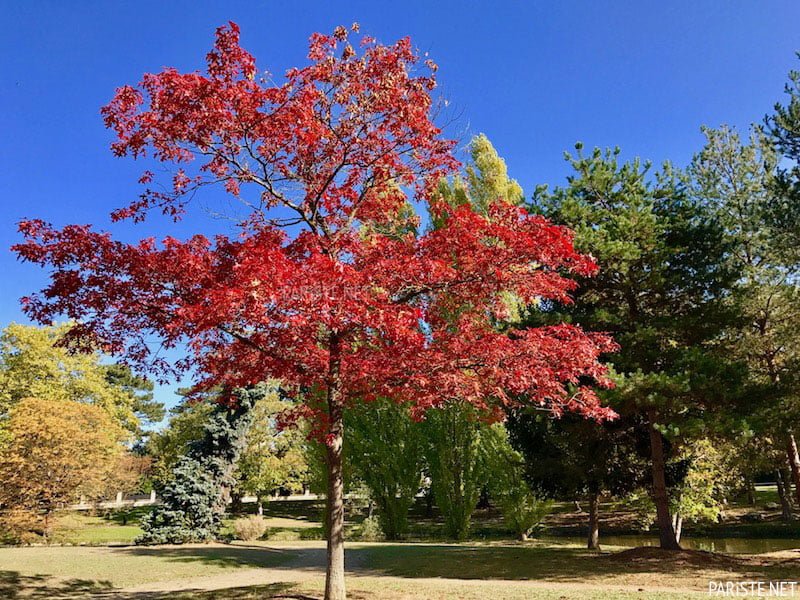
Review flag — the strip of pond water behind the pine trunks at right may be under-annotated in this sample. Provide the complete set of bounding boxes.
[541,534,800,554]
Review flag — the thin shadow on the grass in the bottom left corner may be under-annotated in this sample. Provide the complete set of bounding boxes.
[0,571,317,600]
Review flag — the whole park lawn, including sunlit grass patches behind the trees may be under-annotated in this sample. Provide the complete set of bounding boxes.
[0,488,800,600]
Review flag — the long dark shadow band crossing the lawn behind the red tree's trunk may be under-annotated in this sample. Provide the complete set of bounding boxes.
[109,543,800,582]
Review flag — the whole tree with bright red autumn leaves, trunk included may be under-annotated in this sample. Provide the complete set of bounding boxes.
[15,23,612,599]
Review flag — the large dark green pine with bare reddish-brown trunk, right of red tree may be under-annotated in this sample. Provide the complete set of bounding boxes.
[531,144,737,549]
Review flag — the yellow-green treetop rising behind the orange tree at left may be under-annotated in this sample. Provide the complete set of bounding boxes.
[0,323,159,432]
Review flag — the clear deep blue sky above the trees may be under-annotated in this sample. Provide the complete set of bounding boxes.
[0,0,800,412]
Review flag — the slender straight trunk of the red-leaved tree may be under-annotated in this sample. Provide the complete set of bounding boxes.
[325,334,347,600]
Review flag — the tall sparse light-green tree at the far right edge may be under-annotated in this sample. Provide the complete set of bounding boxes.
[690,125,800,501]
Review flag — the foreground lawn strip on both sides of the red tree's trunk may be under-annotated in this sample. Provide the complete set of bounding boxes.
[0,542,800,599]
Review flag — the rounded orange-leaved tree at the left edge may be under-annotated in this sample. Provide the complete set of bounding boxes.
[0,398,126,540]
